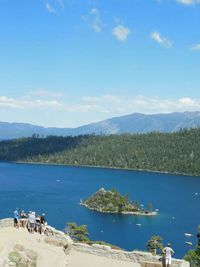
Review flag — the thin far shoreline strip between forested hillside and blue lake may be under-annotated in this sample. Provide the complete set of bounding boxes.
[9,161,200,177]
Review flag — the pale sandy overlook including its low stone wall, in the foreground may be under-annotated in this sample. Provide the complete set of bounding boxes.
[0,219,189,267]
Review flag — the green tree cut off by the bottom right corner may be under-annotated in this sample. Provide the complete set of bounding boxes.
[184,225,200,267]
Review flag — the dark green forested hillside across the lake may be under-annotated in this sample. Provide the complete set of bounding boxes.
[0,129,200,175]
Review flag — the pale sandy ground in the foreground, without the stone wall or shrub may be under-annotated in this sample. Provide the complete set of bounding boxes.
[0,227,140,267]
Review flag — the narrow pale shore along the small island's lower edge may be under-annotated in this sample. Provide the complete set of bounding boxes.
[80,202,158,216]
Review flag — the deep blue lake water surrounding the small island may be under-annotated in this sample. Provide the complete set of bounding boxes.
[0,162,200,257]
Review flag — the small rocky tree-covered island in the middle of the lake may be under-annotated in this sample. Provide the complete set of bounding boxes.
[80,188,157,216]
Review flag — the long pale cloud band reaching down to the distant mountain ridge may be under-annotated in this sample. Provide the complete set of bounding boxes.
[0,94,200,127]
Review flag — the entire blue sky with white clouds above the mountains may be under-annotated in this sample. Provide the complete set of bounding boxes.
[0,0,200,127]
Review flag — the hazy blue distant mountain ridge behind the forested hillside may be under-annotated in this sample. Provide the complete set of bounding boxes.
[0,111,200,140]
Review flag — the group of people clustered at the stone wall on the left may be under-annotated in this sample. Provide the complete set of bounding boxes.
[14,208,47,235]
